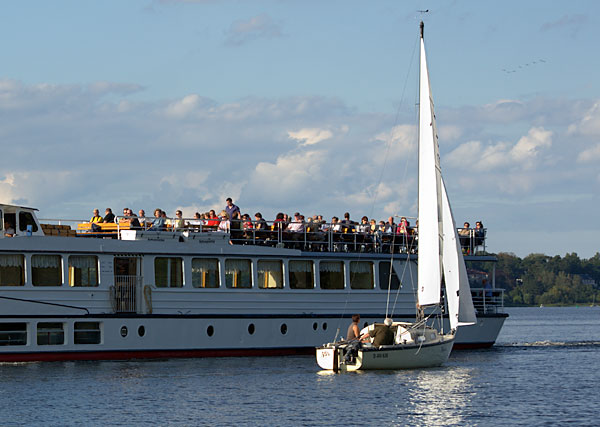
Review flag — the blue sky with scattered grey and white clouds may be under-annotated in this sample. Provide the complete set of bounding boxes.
[0,0,600,258]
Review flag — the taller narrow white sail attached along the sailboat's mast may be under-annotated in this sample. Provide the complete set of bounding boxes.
[417,23,442,306]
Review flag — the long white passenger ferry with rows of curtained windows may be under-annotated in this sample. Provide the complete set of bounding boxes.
[0,204,507,362]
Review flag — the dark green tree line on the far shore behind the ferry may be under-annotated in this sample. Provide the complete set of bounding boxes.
[468,252,600,305]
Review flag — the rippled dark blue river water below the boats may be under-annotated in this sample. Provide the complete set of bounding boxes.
[0,307,600,426]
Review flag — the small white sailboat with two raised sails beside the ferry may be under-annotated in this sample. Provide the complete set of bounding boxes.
[316,22,477,372]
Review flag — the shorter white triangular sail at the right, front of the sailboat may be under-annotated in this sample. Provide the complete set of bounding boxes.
[442,178,477,329]
